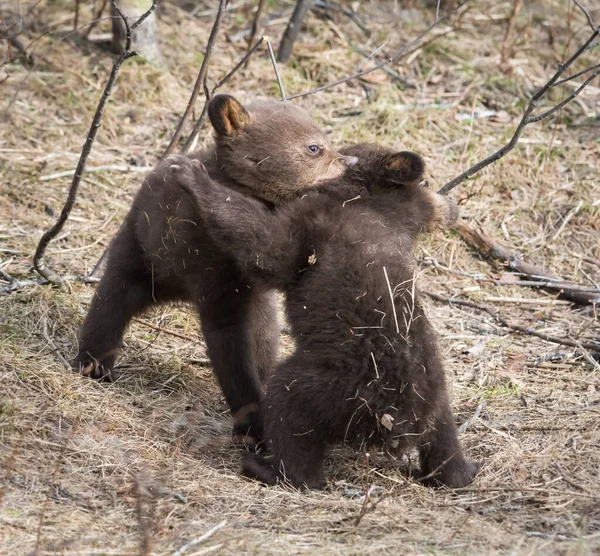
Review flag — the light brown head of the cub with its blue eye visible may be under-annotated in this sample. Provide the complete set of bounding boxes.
[208,95,358,202]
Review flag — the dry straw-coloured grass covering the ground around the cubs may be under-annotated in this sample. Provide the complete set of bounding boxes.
[0,0,600,554]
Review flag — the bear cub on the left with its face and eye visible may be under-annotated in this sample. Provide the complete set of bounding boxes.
[74,95,356,444]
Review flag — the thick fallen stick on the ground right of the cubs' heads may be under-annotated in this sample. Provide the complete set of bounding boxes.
[454,222,600,305]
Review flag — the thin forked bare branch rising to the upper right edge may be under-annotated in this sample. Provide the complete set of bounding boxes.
[438,21,600,194]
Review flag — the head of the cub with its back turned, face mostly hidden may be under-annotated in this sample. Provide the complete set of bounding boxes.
[342,143,458,232]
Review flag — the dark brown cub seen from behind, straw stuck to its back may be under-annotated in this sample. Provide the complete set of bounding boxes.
[166,145,479,488]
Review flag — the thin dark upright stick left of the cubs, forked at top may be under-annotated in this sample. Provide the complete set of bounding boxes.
[33,0,157,285]
